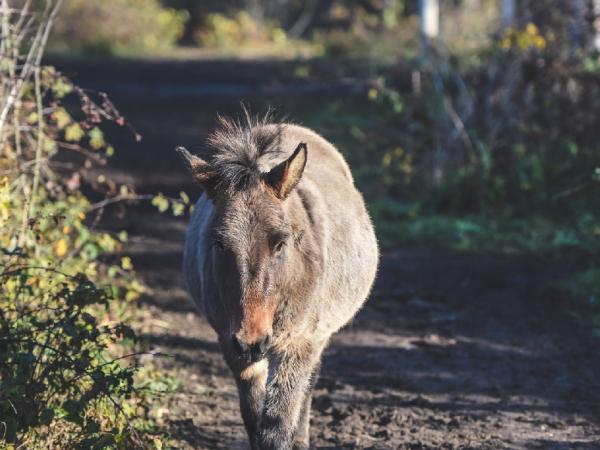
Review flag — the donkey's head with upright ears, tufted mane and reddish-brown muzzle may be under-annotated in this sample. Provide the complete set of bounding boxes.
[173,121,307,362]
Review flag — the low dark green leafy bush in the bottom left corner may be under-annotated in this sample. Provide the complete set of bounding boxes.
[0,264,135,448]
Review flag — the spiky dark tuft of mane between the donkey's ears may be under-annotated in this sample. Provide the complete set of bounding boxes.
[208,108,283,192]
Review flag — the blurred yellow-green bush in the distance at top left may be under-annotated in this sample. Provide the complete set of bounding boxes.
[50,0,188,55]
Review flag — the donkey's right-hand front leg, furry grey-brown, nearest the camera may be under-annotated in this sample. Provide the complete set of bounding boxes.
[258,350,318,450]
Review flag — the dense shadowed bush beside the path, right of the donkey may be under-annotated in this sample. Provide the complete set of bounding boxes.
[307,23,600,252]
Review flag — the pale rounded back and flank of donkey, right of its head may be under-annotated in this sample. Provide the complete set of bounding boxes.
[274,125,378,338]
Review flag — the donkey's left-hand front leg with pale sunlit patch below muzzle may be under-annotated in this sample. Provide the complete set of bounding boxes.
[234,359,268,450]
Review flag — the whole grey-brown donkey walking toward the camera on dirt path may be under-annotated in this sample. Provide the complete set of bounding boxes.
[177,112,379,450]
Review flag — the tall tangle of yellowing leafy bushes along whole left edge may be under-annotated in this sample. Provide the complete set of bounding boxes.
[0,2,155,449]
